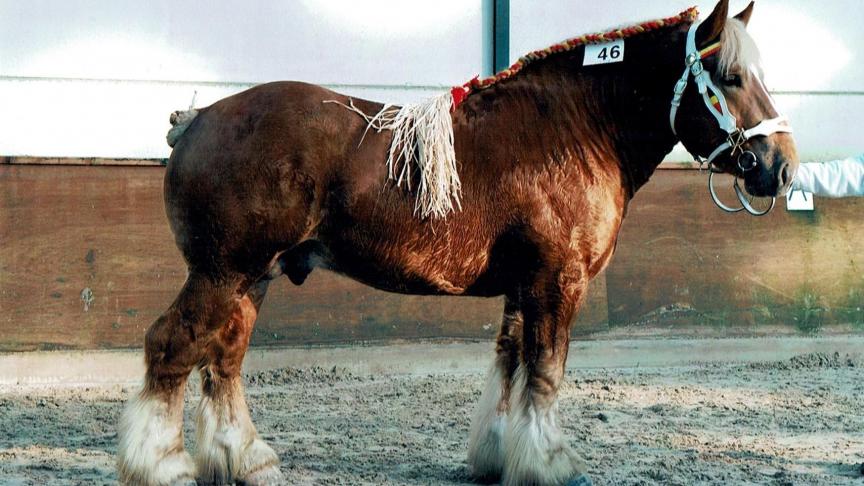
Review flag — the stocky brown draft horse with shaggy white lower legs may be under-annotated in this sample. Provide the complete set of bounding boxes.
[119,0,797,485]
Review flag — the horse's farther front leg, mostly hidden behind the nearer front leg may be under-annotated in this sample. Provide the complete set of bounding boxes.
[468,297,522,482]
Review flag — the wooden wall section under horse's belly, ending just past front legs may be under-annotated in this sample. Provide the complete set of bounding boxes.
[253,271,608,345]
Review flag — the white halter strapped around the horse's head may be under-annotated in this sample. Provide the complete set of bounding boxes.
[669,22,792,165]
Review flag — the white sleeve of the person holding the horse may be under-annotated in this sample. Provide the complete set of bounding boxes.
[792,154,864,197]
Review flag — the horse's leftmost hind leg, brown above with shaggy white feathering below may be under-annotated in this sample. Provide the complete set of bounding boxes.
[118,273,241,486]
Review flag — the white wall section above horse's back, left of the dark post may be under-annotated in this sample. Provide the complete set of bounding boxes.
[0,0,484,157]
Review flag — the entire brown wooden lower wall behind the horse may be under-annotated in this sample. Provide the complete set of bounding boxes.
[0,164,864,350]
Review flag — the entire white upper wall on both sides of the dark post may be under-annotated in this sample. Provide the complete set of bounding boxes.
[0,0,864,160]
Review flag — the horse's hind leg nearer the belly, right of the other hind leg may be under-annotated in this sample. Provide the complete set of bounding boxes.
[195,280,284,486]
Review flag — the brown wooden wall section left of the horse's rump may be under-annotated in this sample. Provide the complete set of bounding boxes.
[0,165,185,349]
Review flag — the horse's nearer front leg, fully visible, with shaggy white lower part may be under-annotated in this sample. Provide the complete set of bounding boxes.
[502,265,591,486]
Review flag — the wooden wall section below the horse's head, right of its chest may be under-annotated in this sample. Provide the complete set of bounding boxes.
[606,171,864,332]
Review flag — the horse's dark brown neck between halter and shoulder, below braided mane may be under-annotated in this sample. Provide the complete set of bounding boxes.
[486,29,680,197]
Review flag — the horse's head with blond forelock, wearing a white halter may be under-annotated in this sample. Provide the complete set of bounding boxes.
[670,0,798,196]
